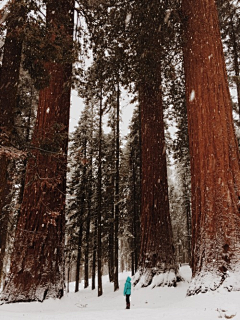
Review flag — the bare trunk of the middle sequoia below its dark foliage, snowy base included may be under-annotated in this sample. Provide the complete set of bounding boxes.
[134,79,177,286]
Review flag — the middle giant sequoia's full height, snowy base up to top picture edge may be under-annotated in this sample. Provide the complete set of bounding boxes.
[132,1,178,286]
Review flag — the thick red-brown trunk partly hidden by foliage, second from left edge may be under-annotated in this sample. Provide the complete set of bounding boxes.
[1,0,74,302]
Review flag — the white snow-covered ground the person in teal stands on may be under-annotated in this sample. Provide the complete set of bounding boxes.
[0,266,240,320]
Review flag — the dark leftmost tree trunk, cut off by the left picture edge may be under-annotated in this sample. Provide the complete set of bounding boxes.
[0,0,26,285]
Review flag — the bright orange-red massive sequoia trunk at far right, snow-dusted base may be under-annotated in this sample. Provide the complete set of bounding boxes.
[182,0,240,295]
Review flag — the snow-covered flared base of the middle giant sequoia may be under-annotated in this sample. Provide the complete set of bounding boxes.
[132,268,183,288]
